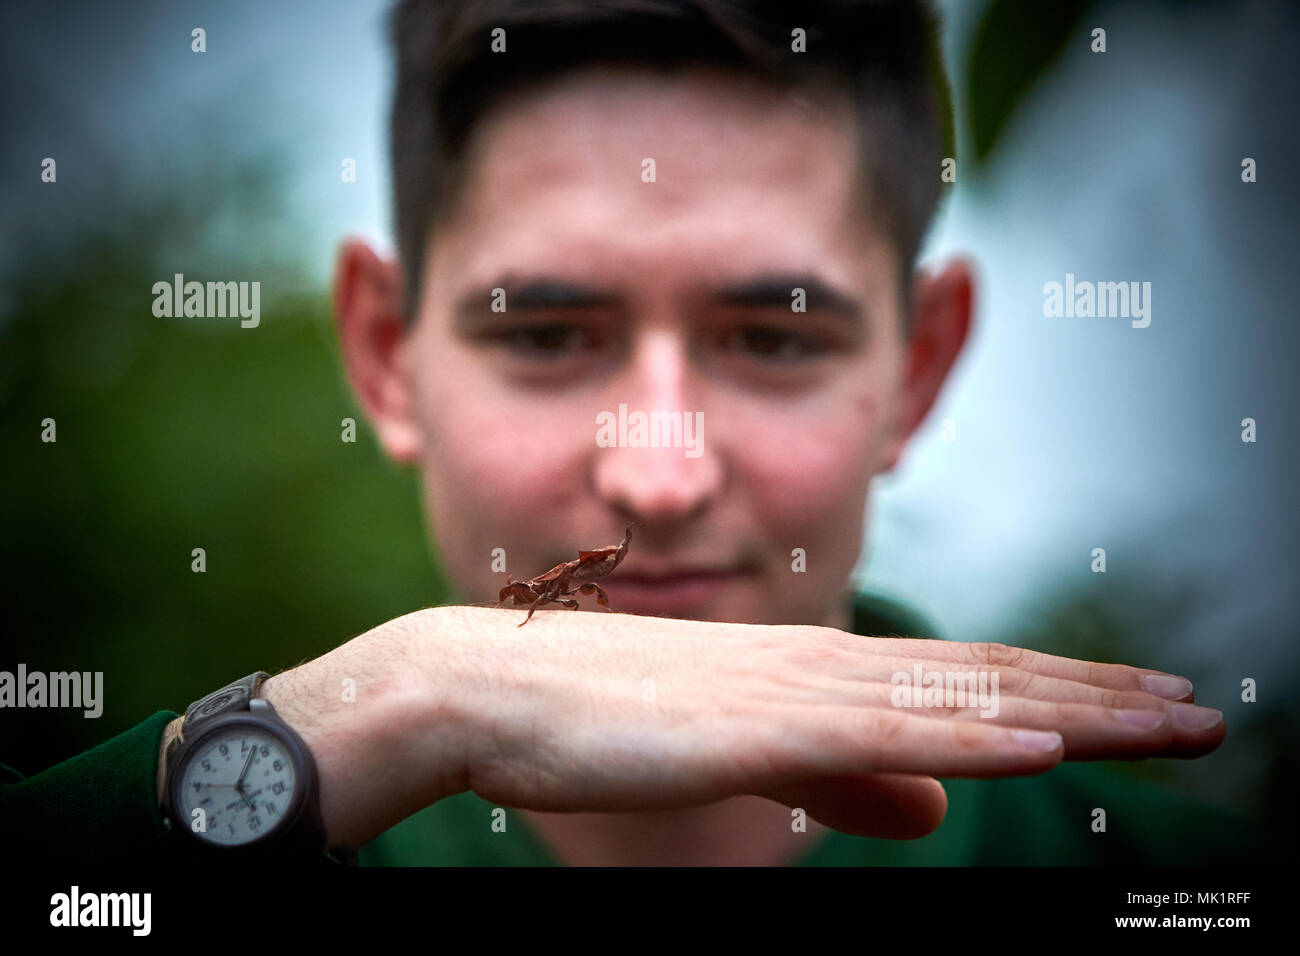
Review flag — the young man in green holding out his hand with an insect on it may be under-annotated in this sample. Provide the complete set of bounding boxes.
[0,0,1253,864]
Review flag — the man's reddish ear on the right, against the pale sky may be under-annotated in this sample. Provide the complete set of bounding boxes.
[885,259,975,470]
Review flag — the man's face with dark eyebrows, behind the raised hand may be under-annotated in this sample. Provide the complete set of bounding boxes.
[381,70,946,627]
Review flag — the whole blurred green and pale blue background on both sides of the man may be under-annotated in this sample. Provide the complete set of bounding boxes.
[0,0,1300,858]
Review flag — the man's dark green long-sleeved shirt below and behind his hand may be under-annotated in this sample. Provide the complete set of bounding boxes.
[0,596,1281,866]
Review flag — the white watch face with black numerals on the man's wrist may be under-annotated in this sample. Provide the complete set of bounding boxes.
[176,723,296,847]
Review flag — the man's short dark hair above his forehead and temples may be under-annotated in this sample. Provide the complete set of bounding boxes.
[390,0,954,321]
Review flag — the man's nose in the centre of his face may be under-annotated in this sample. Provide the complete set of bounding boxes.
[593,329,723,524]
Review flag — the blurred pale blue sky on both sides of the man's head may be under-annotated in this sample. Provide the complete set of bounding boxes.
[0,0,1300,683]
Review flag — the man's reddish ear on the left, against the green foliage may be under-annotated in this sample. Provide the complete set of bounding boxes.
[334,239,420,464]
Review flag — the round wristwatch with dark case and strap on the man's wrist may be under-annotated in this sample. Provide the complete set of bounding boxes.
[163,671,356,866]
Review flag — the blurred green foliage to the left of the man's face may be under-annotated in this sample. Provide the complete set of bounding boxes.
[0,164,446,774]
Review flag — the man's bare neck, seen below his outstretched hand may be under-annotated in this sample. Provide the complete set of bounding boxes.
[520,596,853,866]
